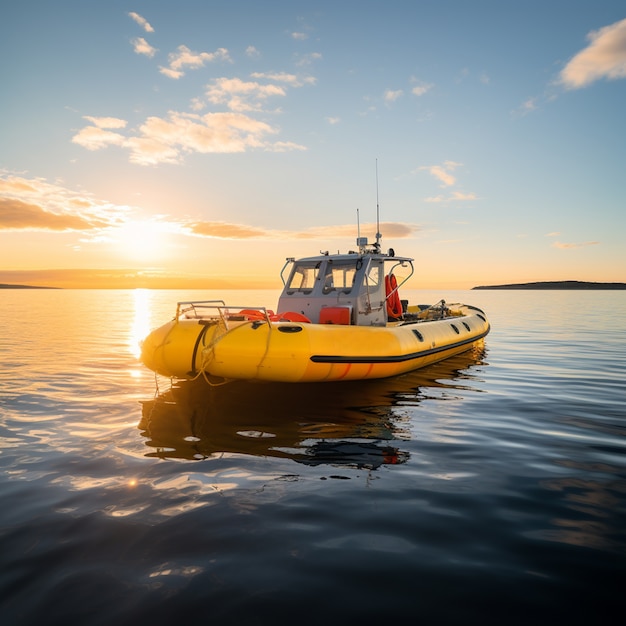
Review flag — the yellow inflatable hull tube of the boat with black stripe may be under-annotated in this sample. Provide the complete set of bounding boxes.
[141,311,489,383]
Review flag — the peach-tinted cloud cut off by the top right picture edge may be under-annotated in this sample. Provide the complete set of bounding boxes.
[559,18,626,89]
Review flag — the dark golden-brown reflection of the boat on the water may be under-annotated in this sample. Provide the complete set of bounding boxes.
[138,346,484,469]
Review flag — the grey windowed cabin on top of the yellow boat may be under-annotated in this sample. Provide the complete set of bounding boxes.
[277,241,413,326]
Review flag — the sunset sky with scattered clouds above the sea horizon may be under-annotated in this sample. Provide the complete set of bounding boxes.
[0,0,626,289]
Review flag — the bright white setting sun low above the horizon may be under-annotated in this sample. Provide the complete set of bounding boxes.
[112,220,168,263]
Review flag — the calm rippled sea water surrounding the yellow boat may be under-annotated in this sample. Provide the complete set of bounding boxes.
[0,290,626,626]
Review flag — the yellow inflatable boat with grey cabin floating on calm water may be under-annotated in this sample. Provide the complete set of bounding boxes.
[141,234,490,384]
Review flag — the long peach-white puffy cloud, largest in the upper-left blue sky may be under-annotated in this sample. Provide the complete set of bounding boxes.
[72,111,306,165]
